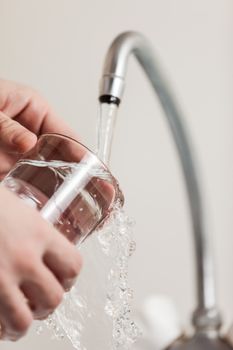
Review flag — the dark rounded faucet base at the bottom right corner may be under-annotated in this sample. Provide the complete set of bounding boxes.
[167,334,233,350]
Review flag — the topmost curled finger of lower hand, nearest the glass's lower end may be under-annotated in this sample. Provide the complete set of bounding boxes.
[43,233,82,290]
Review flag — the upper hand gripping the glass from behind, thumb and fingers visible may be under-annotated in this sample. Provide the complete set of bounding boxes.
[0,79,77,179]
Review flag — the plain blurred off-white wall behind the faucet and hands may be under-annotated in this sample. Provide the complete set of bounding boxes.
[0,0,233,350]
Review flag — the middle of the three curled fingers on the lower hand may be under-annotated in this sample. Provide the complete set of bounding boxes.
[20,263,64,319]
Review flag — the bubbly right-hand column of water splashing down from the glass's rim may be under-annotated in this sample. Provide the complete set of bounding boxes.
[99,204,141,350]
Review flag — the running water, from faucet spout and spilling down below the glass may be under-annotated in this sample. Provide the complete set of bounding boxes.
[32,104,140,350]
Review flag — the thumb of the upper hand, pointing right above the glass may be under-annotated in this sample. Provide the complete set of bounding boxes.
[0,112,37,153]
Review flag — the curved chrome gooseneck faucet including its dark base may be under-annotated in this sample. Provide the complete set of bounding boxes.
[99,32,232,350]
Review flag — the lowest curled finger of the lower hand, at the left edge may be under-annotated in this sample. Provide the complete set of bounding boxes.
[0,283,33,340]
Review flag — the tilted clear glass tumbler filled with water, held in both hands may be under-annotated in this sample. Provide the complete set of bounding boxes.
[2,134,124,244]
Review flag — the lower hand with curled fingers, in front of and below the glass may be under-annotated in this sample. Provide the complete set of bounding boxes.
[0,186,82,340]
